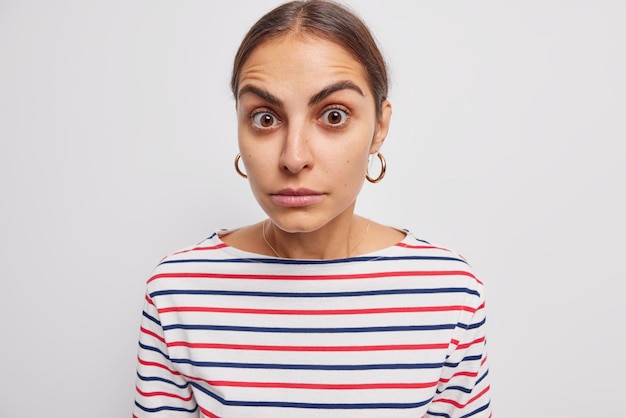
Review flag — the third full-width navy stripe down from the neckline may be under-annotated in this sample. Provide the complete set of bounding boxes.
[163,324,455,334]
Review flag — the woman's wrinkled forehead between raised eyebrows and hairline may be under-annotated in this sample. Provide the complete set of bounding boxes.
[238,34,371,99]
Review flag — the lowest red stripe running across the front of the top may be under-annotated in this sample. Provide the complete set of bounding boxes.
[194,380,437,390]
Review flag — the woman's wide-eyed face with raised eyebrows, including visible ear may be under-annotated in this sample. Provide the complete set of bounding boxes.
[237,35,391,232]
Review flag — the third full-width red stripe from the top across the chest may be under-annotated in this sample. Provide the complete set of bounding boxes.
[167,341,448,352]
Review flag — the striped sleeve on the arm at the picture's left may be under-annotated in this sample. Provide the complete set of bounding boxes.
[133,295,199,418]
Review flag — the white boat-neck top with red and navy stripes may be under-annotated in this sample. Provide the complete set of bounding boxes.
[133,233,491,418]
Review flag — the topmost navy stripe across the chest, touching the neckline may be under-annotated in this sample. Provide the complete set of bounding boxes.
[159,255,468,265]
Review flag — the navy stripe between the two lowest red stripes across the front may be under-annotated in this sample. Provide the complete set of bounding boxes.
[171,358,442,371]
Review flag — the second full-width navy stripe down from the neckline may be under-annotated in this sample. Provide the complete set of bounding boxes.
[150,287,480,299]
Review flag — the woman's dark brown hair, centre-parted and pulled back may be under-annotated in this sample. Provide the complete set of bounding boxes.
[230,0,389,116]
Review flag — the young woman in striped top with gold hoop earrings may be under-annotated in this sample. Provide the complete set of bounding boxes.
[134,0,491,418]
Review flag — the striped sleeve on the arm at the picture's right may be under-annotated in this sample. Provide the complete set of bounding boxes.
[425,282,491,418]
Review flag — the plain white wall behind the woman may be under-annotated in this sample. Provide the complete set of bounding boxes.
[0,0,626,418]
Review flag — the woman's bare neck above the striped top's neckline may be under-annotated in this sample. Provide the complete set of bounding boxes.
[262,214,370,260]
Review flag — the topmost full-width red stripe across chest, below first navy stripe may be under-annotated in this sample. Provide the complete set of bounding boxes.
[148,270,481,283]
